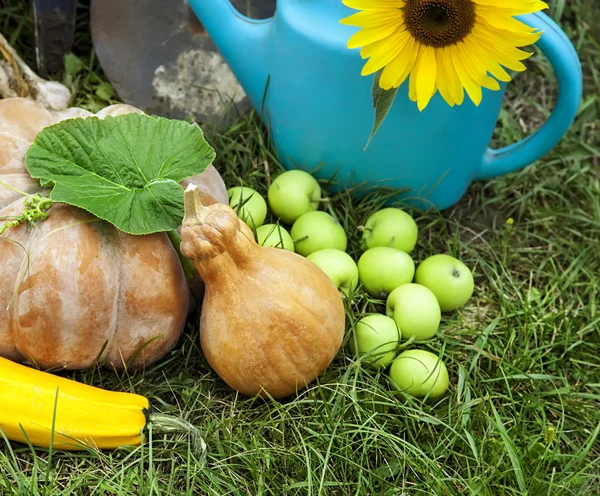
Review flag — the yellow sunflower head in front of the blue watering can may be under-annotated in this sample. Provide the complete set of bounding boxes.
[340,0,548,110]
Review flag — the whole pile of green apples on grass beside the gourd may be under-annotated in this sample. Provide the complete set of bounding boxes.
[228,170,474,400]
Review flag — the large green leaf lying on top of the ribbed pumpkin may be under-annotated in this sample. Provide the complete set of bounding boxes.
[25,113,215,234]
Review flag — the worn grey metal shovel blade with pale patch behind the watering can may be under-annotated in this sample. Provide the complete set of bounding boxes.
[90,0,276,124]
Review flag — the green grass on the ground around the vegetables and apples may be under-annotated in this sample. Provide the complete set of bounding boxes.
[0,0,600,496]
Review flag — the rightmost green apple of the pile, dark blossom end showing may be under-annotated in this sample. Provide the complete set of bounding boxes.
[415,254,475,312]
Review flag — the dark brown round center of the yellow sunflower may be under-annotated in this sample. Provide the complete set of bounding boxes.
[404,0,475,48]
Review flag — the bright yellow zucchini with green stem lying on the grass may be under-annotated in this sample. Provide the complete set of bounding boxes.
[0,358,206,453]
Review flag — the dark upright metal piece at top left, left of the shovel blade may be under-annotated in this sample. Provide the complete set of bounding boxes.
[33,0,77,77]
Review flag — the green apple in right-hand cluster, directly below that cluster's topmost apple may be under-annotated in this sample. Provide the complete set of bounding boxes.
[358,246,415,298]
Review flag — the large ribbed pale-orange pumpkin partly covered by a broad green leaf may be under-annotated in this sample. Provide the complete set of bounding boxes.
[0,98,227,369]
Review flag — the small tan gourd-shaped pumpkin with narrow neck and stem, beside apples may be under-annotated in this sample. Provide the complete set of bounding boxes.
[181,186,345,398]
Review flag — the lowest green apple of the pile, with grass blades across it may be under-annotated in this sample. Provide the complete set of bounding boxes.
[389,349,449,400]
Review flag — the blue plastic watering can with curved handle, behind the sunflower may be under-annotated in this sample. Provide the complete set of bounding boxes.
[189,0,582,209]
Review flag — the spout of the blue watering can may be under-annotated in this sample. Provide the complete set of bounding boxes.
[188,0,272,107]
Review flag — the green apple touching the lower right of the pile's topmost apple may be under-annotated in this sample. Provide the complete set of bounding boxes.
[290,210,348,257]
